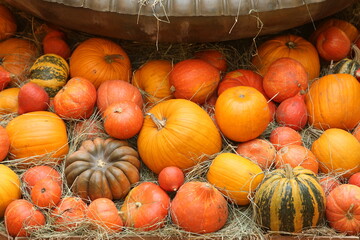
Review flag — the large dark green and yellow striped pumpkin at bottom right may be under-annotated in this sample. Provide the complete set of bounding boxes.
[254,164,325,232]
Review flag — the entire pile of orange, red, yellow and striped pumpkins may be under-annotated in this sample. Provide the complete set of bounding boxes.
[0,2,360,237]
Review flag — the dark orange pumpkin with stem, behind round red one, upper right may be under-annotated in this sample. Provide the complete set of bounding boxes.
[251,34,320,80]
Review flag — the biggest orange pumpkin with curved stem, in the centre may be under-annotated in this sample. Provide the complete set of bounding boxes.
[137,99,222,174]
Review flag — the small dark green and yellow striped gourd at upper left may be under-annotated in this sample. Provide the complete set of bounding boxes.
[29,54,69,97]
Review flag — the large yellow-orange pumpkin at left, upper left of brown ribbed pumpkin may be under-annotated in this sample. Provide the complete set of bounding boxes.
[6,111,69,167]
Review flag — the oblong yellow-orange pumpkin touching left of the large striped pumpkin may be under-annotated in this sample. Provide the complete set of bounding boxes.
[206,153,264,205]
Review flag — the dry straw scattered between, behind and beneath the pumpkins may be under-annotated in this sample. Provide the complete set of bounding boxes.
[0,1,360,239]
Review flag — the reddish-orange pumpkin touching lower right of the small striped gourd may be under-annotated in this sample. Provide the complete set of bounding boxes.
[54,77,96,119]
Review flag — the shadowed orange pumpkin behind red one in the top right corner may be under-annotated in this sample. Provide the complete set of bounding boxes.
[309,18,360,44]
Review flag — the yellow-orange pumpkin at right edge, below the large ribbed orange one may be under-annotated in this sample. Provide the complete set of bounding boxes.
[311,128,360,178]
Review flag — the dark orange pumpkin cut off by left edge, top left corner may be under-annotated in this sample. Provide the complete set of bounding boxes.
[0,5,17,40]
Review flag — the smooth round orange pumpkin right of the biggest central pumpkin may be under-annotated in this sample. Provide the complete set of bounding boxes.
[215,86,270,142]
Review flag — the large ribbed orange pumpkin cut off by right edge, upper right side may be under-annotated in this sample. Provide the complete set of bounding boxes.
[305,74,360,130]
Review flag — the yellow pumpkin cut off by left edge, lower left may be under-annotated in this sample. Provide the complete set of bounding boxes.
[0,164,21,218]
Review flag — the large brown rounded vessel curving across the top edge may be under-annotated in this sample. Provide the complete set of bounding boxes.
[5,0,356,42]
